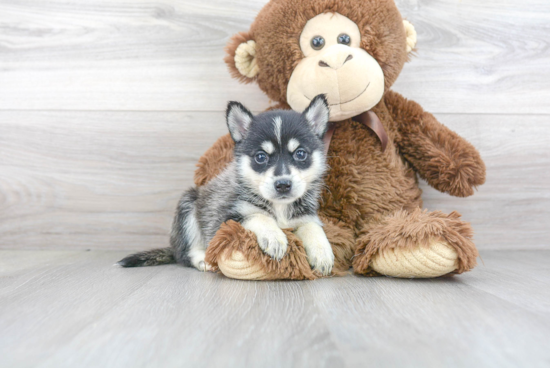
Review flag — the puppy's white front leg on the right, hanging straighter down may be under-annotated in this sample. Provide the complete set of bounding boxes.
[294,222,334,276]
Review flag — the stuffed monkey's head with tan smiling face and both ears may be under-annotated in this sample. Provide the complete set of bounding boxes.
[225,0,416,121]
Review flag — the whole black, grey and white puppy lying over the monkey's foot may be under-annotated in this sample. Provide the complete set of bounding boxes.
[118,95,334,275]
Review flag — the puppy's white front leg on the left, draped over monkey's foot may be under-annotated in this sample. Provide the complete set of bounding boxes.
[242,214,288,261]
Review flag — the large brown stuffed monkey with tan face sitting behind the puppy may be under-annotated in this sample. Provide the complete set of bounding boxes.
[201,0,485,279]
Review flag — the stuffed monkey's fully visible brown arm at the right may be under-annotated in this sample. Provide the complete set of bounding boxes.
[385,91,485,197]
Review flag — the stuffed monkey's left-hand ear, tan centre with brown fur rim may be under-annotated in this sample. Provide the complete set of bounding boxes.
[224,32,259,83]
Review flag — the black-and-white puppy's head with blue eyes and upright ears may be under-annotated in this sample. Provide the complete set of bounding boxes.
[228,96,329,203]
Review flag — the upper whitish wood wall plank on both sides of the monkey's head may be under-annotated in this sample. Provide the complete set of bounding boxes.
[0,0,550,114]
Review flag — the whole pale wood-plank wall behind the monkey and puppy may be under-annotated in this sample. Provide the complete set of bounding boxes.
[0,0,550,249]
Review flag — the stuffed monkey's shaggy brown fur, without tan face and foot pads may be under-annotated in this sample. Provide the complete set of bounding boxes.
[199,0,485,279]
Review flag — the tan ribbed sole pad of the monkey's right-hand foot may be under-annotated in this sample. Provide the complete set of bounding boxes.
[370,241,458,278]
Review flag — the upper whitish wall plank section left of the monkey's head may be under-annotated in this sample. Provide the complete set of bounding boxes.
[0,0,267,111]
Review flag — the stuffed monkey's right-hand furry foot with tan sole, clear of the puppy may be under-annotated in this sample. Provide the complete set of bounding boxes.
[353,209,478,278]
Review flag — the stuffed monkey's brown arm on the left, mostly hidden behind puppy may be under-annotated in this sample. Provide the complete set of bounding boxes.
[194,134,235,187]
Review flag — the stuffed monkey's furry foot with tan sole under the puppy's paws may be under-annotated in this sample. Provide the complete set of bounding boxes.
[206,221,319,280]
